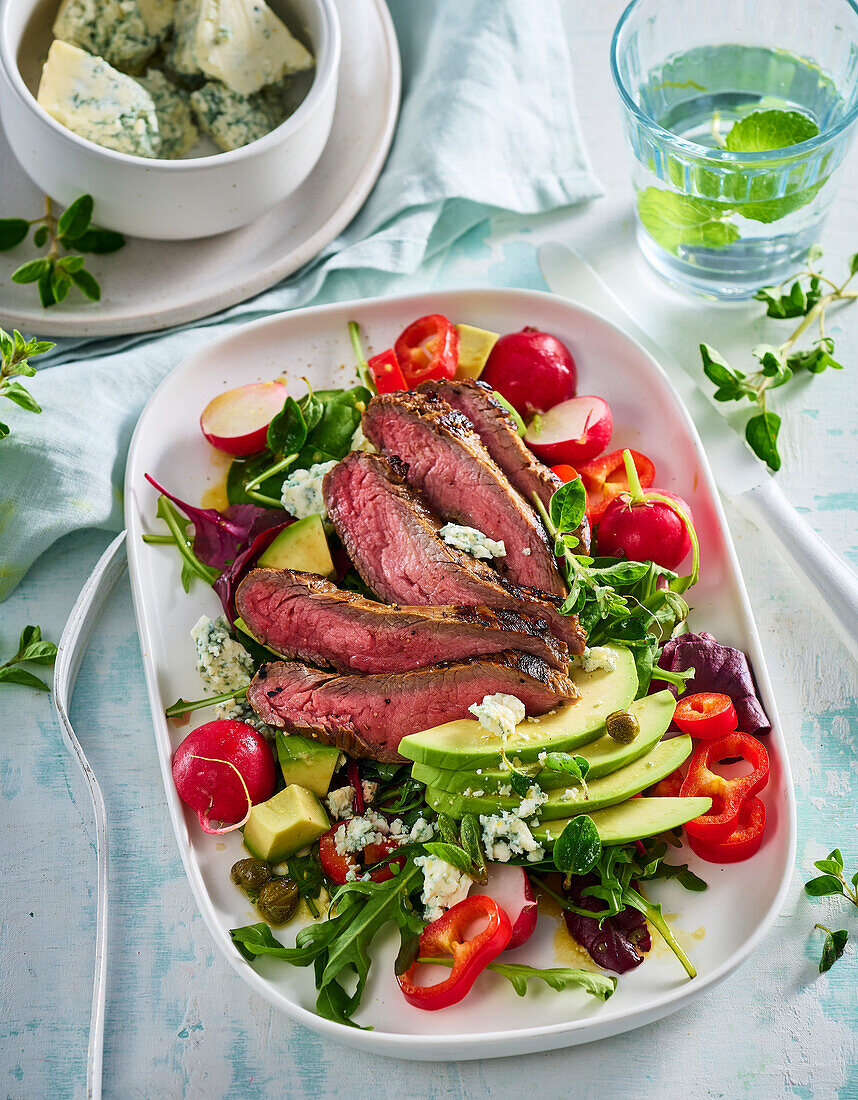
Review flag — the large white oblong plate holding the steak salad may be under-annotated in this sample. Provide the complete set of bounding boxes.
[125,290,795,1059]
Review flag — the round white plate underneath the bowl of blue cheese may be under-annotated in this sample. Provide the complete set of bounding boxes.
[0,0,400,337]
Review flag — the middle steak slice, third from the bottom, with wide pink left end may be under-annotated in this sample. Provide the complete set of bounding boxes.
[322,451,584,653]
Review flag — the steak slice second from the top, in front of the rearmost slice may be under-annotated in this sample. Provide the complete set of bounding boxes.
[363,392,565,596]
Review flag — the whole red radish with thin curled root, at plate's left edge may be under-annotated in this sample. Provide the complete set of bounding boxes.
[173,718,275,833]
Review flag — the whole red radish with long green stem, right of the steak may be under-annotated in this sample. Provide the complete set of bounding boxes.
[596,451,700,584]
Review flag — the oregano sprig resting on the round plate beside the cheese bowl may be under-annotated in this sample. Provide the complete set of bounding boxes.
[0,195,125,309]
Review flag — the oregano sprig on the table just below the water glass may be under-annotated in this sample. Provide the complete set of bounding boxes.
[700,248,858,472]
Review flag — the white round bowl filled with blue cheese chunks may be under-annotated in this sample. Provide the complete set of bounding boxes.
[0,0,340,240]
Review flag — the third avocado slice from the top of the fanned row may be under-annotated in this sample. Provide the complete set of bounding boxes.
[426,734,692,821]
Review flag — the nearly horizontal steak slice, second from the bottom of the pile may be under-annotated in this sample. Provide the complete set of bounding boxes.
[235,569,569,672]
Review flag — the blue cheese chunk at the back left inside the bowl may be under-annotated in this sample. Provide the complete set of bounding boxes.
[54,0,163,72]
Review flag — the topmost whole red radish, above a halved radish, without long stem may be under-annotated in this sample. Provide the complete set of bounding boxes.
[480,327,578,419]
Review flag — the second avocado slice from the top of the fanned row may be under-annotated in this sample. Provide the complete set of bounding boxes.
[411,691,677,794]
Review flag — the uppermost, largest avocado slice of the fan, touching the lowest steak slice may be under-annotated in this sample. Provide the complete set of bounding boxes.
[398,646,638,771]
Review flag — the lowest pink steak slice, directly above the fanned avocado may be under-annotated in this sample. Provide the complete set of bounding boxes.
[248,653,579,761]
